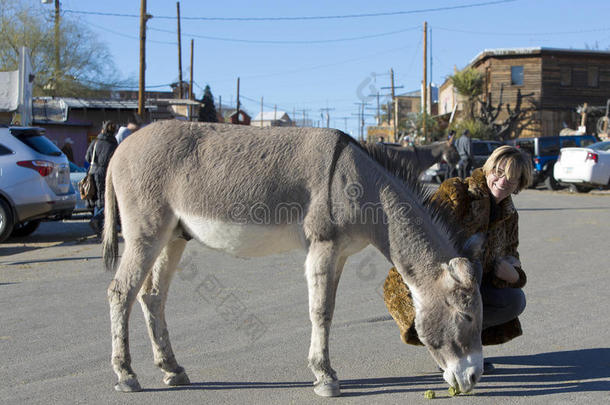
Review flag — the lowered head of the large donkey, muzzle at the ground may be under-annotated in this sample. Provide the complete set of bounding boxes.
[413,235,483,392]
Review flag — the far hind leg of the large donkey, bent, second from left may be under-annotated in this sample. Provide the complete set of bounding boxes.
[138,239,190,386]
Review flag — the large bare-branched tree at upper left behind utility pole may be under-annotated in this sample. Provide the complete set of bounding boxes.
[0,0,127,97]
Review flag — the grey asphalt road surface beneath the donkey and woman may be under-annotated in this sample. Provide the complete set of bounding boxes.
[0,190,610,405]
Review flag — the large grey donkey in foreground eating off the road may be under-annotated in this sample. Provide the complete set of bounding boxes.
[103,121,483,396]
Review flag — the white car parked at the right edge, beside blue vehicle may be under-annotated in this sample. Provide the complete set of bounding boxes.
[553,141,610,191]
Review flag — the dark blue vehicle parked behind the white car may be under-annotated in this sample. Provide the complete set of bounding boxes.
[509,135,597,190]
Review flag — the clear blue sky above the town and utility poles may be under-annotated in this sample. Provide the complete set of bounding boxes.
[53,0,610,135]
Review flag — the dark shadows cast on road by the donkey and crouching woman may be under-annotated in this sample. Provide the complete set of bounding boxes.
[144,348,610,397]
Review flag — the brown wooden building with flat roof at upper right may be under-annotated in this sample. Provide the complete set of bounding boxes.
[466,48,610,137]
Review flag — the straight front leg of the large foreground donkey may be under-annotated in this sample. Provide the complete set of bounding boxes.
[305,242,345,397]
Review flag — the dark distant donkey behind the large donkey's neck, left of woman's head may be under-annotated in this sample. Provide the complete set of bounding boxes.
[375,138,460,177]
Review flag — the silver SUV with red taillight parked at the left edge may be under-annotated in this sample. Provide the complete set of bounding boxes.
[0,127,76,242]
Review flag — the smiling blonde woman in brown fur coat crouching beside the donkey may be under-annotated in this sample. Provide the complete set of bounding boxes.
[384,146,532,372]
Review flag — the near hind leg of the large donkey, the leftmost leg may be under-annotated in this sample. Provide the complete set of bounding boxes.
[108,234,169,392]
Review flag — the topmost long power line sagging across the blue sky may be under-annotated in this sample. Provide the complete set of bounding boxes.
[63,0,517,21]
